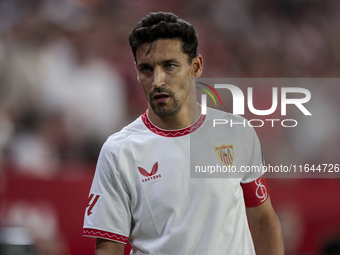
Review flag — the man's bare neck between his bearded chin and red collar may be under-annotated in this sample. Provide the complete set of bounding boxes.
[148,101,201,130]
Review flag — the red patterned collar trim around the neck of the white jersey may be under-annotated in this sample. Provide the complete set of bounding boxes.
[142,112,206,137]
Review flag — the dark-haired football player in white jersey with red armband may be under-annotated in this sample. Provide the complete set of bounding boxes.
[84,13,283,255]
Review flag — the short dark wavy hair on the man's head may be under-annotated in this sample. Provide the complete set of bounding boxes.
[129,12,198,64]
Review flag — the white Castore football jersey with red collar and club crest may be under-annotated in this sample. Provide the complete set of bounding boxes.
[83,108,268,255]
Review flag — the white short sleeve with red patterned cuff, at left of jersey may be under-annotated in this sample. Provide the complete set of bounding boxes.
[83,136,131,243]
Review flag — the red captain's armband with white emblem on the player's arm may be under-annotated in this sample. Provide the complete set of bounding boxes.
[241,176,269,207]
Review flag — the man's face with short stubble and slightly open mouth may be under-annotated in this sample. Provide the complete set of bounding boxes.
[136,39,192,117]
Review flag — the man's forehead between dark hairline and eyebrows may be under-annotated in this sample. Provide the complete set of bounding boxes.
[136,39,187,63]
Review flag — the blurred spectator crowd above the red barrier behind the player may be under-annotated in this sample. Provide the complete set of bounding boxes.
[0,0,340,254]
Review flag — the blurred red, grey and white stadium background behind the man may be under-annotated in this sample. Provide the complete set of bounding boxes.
[0,0,340,255]
